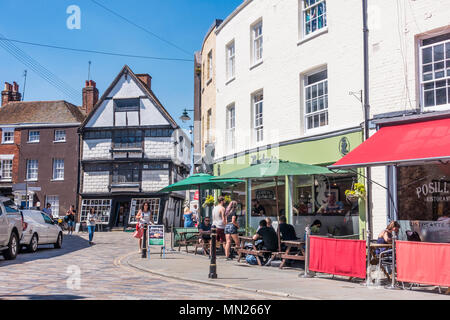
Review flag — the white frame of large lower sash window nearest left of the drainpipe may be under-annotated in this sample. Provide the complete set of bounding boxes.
[303,67,329,133]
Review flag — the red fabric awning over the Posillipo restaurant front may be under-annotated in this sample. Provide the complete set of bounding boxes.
[329,119,450,169]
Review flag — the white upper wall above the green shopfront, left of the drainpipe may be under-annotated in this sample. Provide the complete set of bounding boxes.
[216,0,363,158]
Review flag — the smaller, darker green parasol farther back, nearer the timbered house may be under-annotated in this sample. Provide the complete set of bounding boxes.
[160,173,245,192]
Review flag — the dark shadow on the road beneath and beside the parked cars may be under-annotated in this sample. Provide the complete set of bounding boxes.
[0,235,90,268]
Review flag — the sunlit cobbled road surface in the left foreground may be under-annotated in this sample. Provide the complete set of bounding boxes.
[0,232,282,300]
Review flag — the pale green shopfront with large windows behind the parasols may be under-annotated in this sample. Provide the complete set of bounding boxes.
[214,127,366,238]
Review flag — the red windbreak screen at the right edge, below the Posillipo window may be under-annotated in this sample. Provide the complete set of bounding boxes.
[395,241,450,287]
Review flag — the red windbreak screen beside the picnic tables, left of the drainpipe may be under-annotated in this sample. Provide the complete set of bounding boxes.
[309,237,366,279]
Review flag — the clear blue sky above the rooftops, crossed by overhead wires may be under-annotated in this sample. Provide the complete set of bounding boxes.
[0,0,242,127]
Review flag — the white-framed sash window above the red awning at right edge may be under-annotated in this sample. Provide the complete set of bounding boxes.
[420,33,450,107]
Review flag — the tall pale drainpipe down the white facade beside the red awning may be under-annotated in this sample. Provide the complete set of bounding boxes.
[362,0,372,239]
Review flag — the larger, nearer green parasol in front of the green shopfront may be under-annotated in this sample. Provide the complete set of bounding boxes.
[212,160,334,181]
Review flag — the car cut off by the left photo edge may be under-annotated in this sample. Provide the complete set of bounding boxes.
[0,197,25,260]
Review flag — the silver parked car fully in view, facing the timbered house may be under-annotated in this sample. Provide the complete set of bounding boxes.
[21,210,63,252]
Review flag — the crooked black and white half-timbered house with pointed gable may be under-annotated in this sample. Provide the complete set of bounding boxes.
[79,66,191,228]
